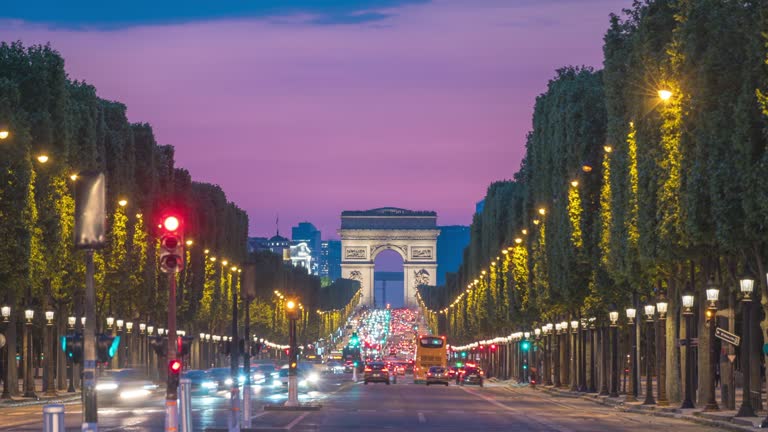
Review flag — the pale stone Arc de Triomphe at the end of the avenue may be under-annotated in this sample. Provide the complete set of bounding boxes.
[339,207,440,307]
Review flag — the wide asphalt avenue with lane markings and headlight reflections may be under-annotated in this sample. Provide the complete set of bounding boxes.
[0,375,732,432]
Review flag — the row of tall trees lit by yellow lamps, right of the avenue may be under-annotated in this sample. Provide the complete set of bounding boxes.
[420,0,768,404]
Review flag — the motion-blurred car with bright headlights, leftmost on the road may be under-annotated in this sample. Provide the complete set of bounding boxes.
[96,369,158,404]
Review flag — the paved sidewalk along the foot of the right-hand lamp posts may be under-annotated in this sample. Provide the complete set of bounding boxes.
[520,382,763,431]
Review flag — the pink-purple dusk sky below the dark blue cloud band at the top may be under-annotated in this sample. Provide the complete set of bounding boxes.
[0,0,631,238]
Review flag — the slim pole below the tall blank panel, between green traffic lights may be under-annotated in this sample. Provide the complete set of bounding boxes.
[82,249,99,432]
